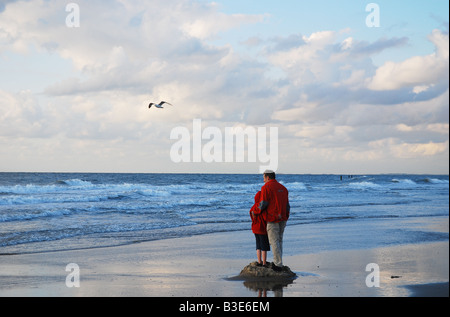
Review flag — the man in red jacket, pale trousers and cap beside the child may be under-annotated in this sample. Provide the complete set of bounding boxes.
[259,170,291,271]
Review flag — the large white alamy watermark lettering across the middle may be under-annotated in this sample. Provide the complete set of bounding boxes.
[170,119,278,173]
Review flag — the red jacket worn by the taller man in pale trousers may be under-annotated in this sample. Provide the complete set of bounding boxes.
[259,179,291,222]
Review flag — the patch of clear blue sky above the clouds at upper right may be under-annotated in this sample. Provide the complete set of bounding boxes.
[217,0,448,62]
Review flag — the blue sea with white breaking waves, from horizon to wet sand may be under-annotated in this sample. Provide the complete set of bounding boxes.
[0,173,449,255]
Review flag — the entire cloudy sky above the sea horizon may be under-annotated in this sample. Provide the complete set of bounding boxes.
[0,0,449,175]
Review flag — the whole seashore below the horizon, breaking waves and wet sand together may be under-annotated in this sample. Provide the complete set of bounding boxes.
[0,173,449,298]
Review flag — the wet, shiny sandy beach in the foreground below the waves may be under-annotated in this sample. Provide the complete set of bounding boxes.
[0,221,449,297]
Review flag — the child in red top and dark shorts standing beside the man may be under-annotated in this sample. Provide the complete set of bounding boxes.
[250,191,270,266]
